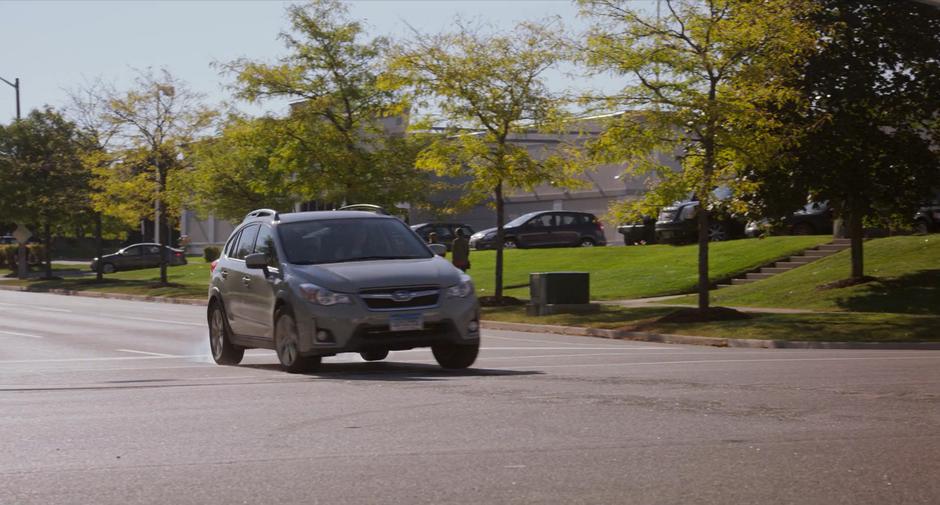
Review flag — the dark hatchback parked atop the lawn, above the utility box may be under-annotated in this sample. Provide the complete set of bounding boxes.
[470,210,607,249]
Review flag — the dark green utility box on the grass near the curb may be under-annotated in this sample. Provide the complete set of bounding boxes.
[527,272,600,316]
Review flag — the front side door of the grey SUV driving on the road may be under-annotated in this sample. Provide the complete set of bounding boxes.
[240,224,281,339]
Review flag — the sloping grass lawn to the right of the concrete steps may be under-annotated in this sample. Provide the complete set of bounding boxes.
[677,234,940,315]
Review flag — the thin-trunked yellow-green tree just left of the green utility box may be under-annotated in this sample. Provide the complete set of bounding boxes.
[388,22,574,300]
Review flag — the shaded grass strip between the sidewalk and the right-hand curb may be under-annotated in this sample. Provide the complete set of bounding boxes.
[483,306,940,342]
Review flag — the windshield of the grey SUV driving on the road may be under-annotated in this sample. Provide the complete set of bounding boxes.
[278,218,433,265]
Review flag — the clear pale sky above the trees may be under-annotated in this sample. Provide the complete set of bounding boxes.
[0,0,649,123]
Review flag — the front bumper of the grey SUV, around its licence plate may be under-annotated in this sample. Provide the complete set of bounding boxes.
[294,294,480,356]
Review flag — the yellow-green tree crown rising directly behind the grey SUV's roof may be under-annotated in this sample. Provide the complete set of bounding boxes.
[220,0,426,209]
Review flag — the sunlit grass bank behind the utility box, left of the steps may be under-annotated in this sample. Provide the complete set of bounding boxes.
[470,236,831,300]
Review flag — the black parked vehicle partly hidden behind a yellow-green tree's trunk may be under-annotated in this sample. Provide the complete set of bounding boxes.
[656,197,745,244]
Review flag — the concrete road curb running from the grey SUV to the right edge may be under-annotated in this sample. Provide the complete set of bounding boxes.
[481,320,940,350]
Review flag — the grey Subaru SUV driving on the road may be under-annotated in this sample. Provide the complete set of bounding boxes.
[208,209,480,372]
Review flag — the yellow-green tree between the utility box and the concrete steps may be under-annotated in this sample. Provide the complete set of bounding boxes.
[577,0,812,312]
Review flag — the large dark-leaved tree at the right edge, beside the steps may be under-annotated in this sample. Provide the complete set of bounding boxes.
[765,0,940,282]
